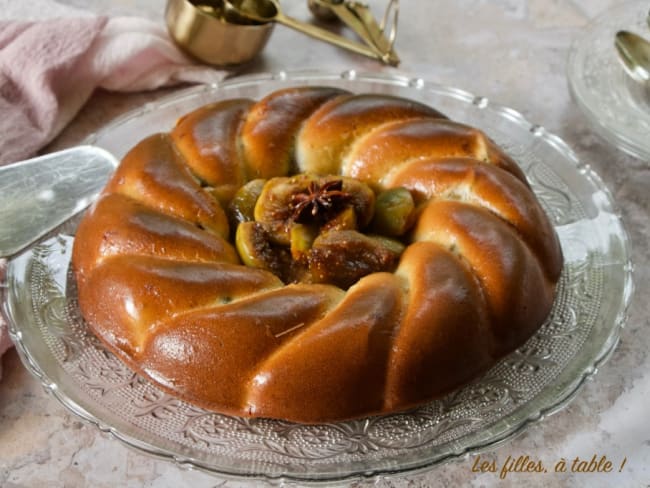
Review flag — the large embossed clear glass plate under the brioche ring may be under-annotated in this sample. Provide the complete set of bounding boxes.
[4,71,633,484]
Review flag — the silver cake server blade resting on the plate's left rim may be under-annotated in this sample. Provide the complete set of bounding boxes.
[0,146,118,257]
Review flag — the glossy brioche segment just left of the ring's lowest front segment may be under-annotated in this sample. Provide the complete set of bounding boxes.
[138,285,341,415]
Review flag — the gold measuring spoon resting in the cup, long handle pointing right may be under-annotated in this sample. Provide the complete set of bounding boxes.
[223,0,399,65]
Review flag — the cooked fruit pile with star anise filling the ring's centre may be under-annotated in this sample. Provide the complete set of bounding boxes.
[229,174,415,289]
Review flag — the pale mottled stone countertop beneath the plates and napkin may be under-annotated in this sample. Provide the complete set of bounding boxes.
[0,0,650,488]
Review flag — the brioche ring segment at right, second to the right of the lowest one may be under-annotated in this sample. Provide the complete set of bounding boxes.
[414,201,555,356]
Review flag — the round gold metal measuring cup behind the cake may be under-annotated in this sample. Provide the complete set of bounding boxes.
[165,0,274,66]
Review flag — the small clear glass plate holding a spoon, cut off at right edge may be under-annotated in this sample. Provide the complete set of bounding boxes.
[567,0,650,160]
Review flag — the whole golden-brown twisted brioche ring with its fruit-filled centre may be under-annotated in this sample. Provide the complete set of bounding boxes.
[73,87,562,423]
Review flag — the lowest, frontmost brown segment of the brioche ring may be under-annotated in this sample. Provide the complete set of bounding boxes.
[247,273,403,422]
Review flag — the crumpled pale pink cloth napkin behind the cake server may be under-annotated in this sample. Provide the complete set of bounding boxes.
[0,13,232,377]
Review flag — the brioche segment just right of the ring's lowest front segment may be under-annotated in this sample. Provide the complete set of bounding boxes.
[384,242,494,410]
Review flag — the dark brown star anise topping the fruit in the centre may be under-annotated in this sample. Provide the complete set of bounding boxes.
[291,180,352,224]
